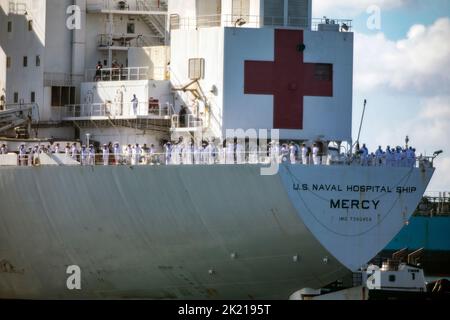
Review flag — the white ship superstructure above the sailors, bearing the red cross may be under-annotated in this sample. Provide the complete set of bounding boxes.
[0,0,353,144]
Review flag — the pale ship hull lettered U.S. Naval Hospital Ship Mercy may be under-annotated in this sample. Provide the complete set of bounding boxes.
[0,165,434,299]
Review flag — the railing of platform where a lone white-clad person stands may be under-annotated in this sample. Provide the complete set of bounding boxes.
[53,101,172,120]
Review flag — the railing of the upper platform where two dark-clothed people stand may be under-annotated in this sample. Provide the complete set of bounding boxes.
[84,67,167,82]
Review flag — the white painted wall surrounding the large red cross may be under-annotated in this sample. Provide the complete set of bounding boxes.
[223,28,353,141]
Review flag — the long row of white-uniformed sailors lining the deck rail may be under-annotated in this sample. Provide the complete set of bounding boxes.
[0,139,416,167]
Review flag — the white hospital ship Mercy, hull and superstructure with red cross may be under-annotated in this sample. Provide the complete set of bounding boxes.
[0,0,434,299]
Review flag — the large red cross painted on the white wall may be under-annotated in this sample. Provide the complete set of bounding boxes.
[244,30,333,129]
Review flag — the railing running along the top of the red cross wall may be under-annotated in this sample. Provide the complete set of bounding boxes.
[170,14,352,31]
